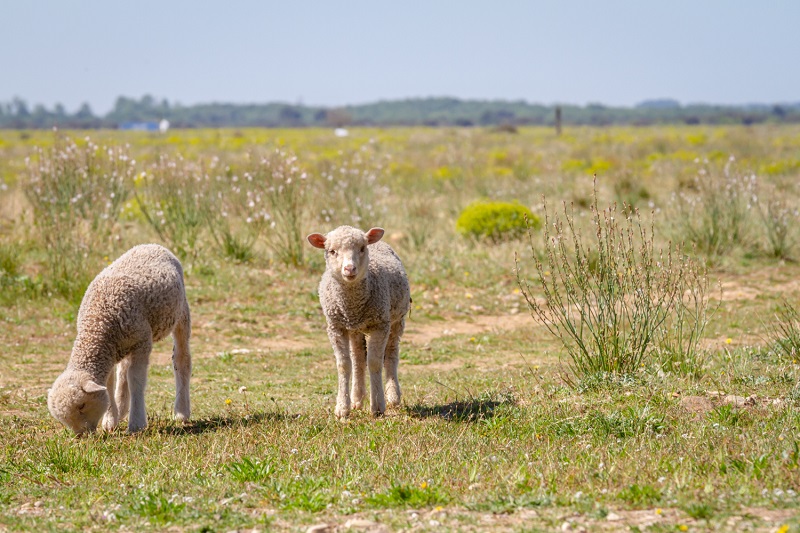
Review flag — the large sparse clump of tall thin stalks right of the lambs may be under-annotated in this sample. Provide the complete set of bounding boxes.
[517,182,692,380]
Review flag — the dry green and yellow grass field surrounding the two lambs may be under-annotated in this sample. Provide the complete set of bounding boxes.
[0,126,800,532]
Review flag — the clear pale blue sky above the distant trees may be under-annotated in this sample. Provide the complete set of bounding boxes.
[0,0,800,113]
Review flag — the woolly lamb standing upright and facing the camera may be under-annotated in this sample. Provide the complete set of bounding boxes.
[308,222,411,418]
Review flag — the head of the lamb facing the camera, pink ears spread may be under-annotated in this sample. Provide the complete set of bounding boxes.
[308,226,383,283]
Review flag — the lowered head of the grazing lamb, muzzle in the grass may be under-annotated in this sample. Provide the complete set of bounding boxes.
[47,368,109,435]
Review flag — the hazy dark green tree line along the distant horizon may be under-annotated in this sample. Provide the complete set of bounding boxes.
[0,95,800,129]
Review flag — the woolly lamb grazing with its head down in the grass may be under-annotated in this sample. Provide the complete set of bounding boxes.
[47,244,192,435]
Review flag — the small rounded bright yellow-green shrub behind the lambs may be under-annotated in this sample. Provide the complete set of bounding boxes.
[456,201,540,242]
